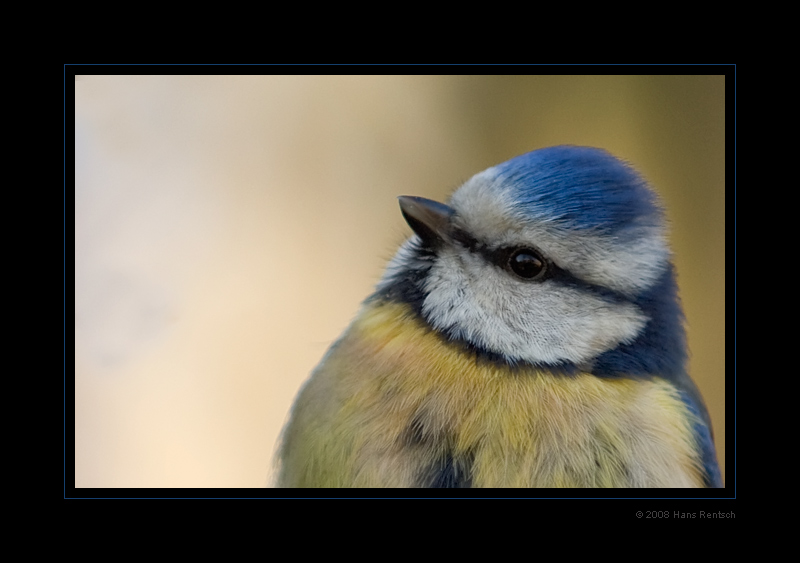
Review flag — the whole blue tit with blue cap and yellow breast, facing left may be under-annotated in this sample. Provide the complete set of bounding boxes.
[277,146,722,488]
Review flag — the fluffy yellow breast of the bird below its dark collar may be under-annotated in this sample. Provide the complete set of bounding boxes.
[279,303,702,487]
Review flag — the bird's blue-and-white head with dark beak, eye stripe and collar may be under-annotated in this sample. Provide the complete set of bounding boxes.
[375,146,685,376]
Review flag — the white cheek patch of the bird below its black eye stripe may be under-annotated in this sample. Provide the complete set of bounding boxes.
[423,251,647,363]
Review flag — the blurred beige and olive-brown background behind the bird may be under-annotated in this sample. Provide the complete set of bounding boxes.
[75,76,725,487]
